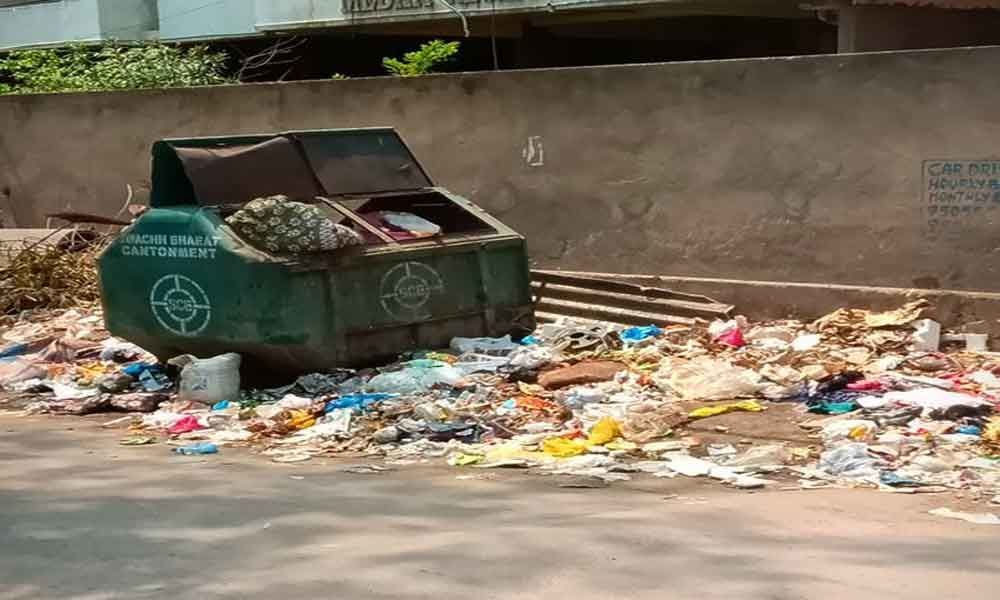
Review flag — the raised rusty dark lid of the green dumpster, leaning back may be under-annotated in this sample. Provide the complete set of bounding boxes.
[150,127,433,206]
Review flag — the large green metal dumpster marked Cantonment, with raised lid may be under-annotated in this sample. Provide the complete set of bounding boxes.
[99,128,534,373]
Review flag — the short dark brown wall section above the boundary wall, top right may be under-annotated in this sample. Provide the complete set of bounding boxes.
[837,6,1000,52]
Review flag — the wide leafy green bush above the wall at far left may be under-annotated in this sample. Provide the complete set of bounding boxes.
[0,44,234,94]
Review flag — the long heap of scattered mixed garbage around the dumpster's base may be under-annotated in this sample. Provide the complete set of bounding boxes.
[0,301,1000,498]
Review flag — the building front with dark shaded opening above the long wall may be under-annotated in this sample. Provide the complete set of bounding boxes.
[0,0,1000,61]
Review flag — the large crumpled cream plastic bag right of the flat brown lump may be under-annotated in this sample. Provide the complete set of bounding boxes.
[658,357,761,400]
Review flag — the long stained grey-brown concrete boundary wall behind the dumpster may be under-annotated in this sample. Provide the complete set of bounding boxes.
[0,48,1000,291]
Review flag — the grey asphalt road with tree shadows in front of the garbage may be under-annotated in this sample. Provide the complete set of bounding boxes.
[0,416,1000,600]
